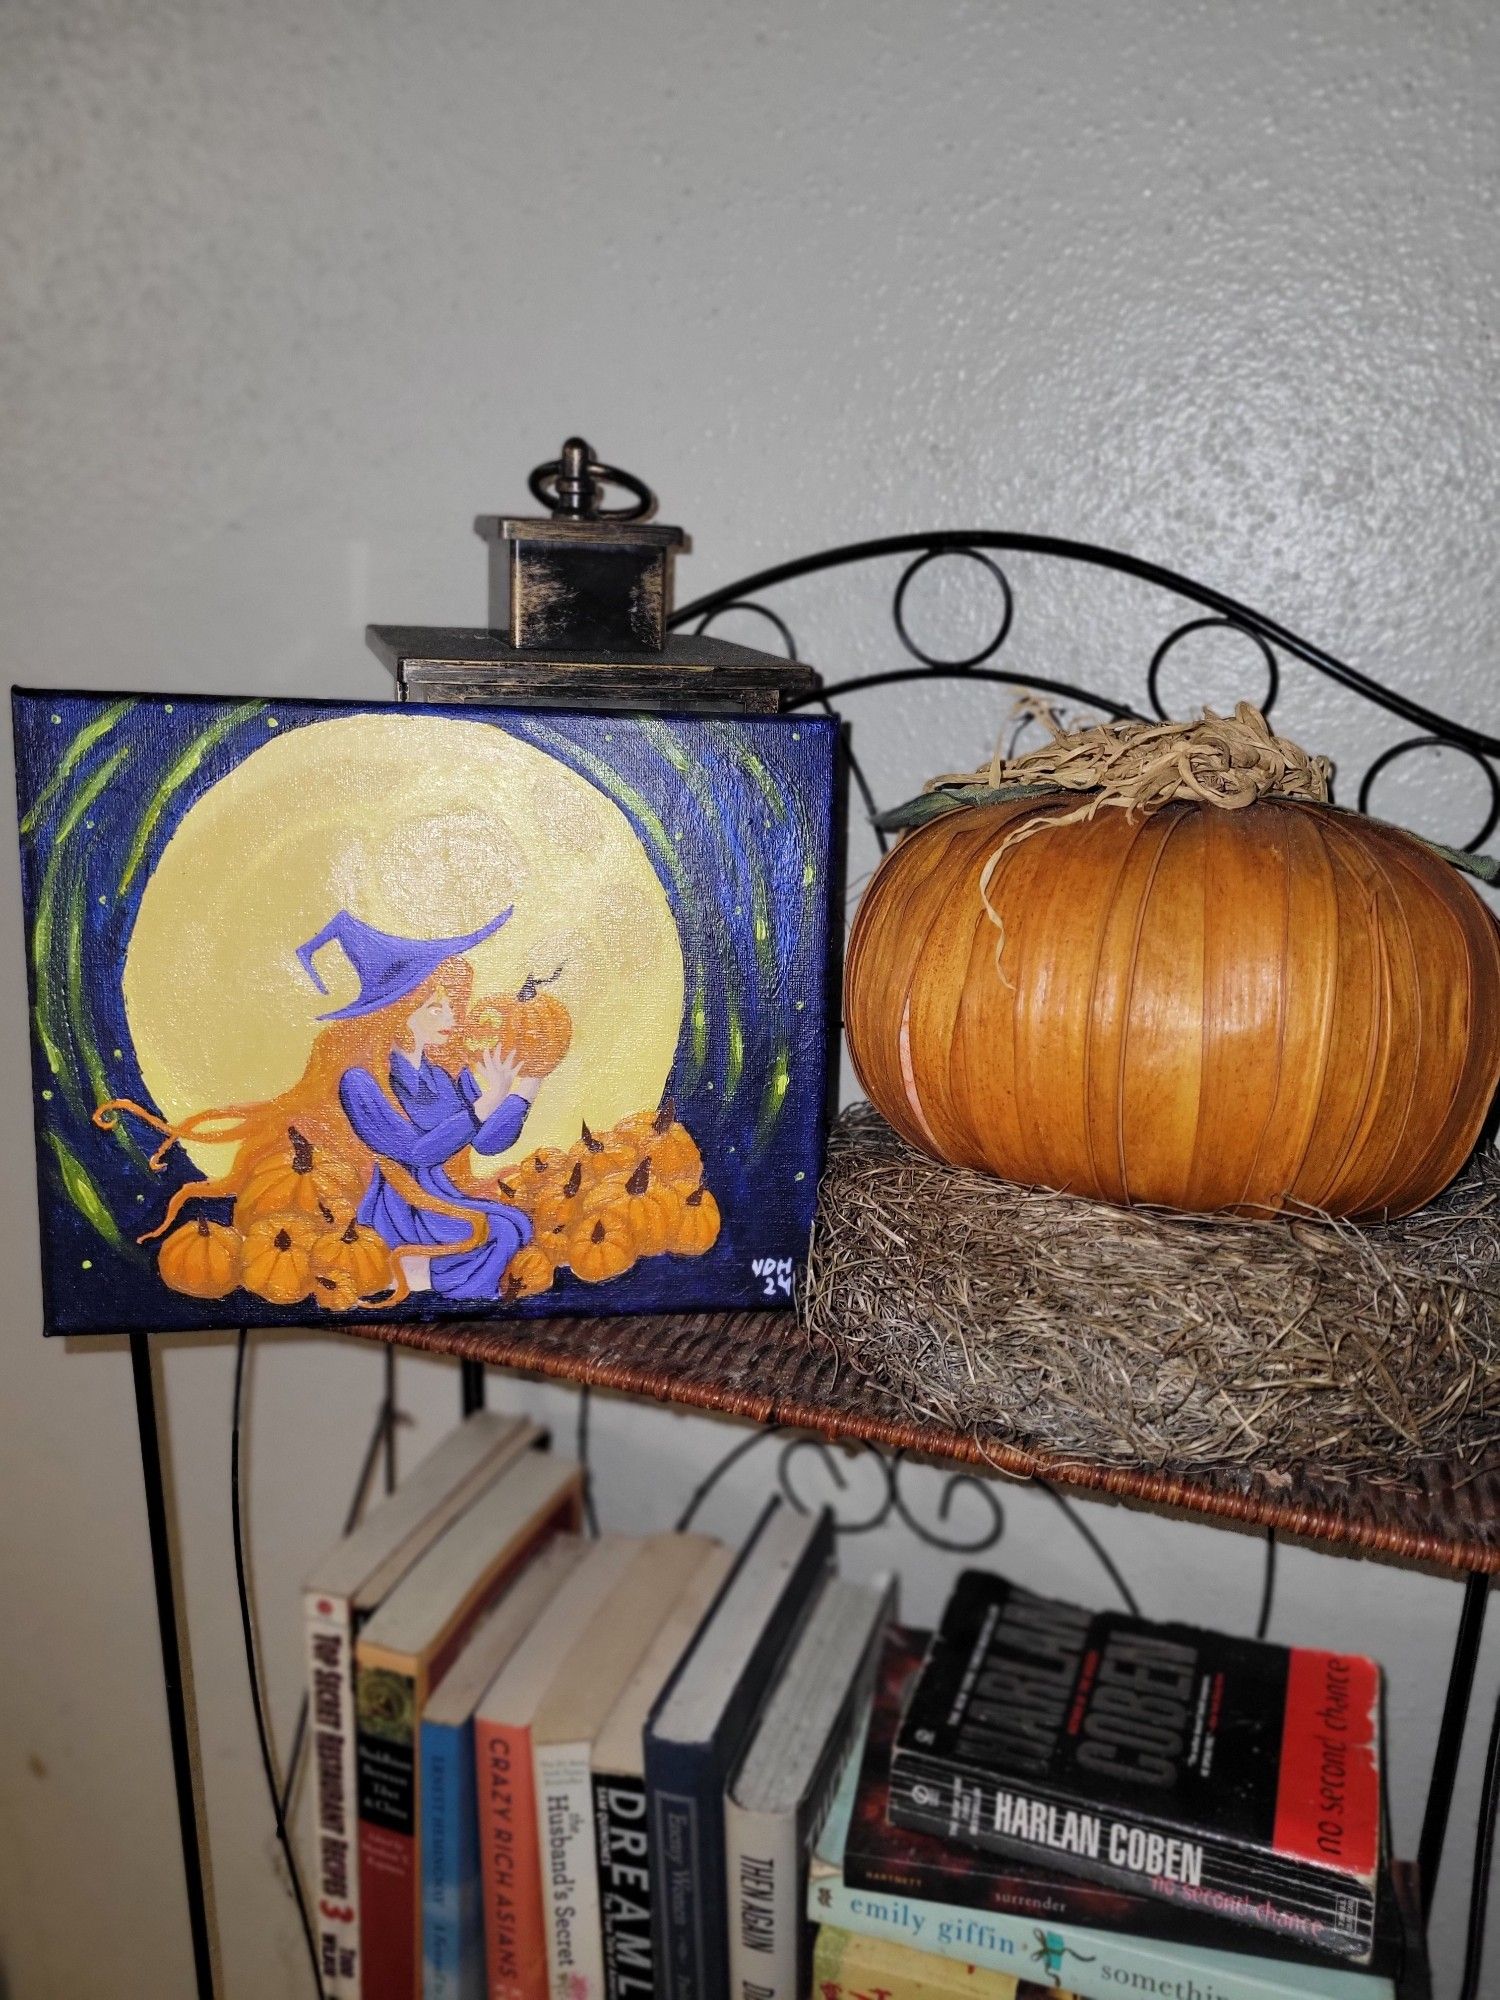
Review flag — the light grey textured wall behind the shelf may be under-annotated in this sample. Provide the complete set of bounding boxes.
[0,0,1500,2000]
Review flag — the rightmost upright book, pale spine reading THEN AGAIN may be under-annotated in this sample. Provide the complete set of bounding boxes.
[724,1576,896,2000]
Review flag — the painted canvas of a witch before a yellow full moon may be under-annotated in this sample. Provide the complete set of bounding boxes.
[14,690,836,1334]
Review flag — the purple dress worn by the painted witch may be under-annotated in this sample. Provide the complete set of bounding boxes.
[338,1050,532,1298]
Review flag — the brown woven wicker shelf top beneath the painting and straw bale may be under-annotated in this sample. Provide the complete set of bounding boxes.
[352,1312,1500,1574]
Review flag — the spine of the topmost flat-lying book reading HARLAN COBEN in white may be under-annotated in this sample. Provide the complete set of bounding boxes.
[888,1750,1374,1960]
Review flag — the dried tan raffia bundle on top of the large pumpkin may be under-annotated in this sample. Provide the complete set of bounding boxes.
[940,696,1334,984]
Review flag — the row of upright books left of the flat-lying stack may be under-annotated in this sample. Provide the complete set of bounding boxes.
[304,1412,916,2000]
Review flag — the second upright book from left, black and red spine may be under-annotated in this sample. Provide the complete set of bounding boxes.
[354,1452,582,2000]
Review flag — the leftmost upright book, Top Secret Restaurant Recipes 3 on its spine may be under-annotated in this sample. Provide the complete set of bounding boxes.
[302,1410,542,2000]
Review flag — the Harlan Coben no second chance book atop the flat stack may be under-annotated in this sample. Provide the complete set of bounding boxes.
[890,1570,1380,1964]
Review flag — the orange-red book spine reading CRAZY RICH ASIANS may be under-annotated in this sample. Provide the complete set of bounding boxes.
[474,1716,548,2000]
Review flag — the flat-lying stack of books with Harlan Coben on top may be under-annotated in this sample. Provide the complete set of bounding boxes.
[812,1570,1426,2000]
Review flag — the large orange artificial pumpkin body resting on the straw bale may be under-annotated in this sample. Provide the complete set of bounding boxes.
[844,798,1500,1216]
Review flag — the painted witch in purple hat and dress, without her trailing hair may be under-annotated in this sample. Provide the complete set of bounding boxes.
[296,910,540,1300]
